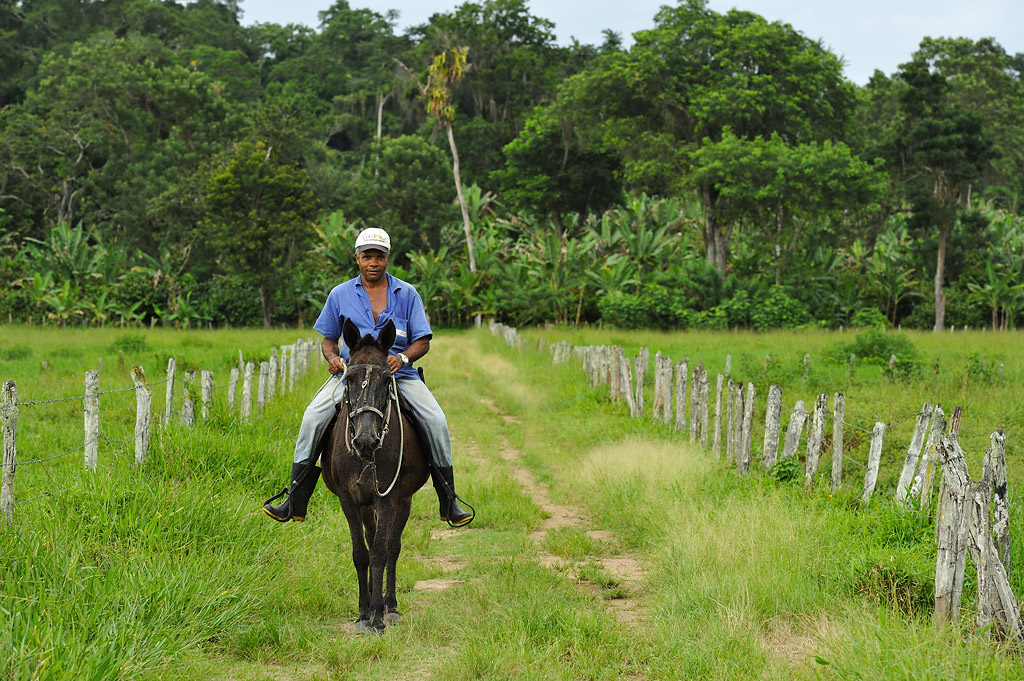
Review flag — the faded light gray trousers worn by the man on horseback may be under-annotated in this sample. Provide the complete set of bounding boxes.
[292,374,452,468]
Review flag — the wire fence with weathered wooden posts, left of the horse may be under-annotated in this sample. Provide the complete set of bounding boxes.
[0,339,318,523]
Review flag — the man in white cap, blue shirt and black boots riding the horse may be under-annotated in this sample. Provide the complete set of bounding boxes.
[263,227,473,526]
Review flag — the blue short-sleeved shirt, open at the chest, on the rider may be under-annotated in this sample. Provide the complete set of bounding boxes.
[313,272,433,378]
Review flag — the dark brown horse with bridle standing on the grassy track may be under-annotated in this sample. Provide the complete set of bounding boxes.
[321,320,429,633]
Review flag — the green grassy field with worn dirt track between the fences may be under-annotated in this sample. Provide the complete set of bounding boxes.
[0,327,1024,680]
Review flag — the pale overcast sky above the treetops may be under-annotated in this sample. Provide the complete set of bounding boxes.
[234,0,1024,85]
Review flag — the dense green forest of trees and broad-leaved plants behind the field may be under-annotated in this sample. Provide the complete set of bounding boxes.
[0,0,1024,330]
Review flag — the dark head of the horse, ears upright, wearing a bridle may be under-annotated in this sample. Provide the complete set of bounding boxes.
[341,320,395,462]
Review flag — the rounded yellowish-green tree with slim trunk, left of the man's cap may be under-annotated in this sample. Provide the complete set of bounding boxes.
[202,141,316,327]
